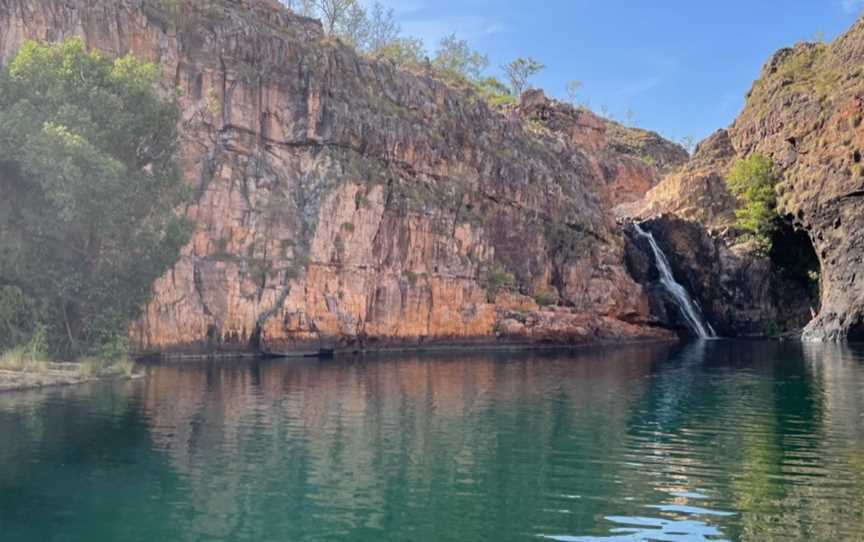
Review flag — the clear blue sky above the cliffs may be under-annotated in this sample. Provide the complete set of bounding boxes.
[382,0,864,146]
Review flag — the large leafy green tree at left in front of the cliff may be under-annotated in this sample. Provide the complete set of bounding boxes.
[0,39,189,359]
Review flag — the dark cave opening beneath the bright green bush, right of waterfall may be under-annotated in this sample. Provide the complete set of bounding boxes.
[770,221,821,306]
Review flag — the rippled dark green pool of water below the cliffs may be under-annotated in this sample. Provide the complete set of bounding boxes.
[0,341,864,542]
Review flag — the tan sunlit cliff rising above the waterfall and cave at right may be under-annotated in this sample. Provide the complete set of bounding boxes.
[616,20,864,340]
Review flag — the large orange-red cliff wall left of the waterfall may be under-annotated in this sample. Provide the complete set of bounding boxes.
[0,0,683,352]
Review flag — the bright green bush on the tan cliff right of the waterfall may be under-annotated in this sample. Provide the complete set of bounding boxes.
[726,153,779,254]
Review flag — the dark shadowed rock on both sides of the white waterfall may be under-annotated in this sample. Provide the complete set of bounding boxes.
[627,215,815,337]
